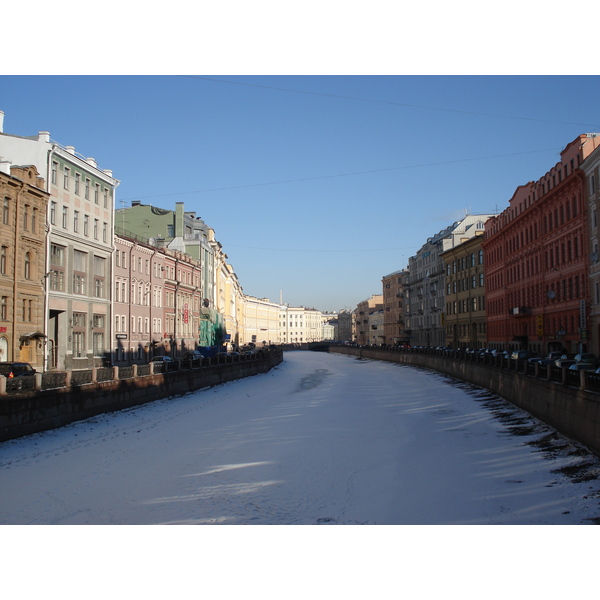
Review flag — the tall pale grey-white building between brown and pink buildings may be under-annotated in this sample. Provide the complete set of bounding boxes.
[0,114,119,370]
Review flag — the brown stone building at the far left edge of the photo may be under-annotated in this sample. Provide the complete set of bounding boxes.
[0,162,49,371]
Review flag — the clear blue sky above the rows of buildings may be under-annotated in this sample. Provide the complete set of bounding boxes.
[0,74,600,310]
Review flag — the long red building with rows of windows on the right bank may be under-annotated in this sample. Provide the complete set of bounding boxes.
[483,134,600,354]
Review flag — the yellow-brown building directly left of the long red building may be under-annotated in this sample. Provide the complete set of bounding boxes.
[441,234,487,348]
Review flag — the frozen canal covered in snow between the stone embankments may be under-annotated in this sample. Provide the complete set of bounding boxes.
[0,352,600,525]
